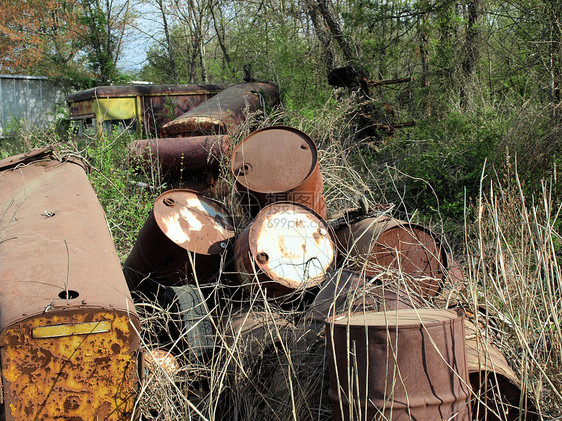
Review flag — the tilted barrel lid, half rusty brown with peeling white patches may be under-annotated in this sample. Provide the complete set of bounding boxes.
[154,189,235,255]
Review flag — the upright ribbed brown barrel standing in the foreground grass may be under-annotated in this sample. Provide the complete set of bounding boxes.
[326,309,471,421]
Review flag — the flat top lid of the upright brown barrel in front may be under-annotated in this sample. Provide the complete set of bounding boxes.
[326,308,460,328]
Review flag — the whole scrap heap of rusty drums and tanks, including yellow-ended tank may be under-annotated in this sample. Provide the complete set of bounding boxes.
[0,83,521,420]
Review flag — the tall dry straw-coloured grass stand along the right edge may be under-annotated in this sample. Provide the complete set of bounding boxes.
[465,167,562,419]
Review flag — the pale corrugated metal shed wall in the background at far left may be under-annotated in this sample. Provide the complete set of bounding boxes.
[0,74,62,138]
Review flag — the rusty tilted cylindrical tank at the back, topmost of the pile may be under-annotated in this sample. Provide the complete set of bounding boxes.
[162,82,279,137]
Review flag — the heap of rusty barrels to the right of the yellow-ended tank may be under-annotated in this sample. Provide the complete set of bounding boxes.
[124,116,520,420]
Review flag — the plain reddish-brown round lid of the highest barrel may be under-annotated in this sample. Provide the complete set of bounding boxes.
[231,126,318,193]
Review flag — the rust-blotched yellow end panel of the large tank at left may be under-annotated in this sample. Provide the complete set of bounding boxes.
[0,309,139,421]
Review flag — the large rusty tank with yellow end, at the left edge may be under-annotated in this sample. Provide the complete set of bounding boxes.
[0,149,140,421]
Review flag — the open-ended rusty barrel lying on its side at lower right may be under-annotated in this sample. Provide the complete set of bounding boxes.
[465,320,534,421]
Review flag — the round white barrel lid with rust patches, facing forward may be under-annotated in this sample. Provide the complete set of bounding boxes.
[249,202,335,289]
